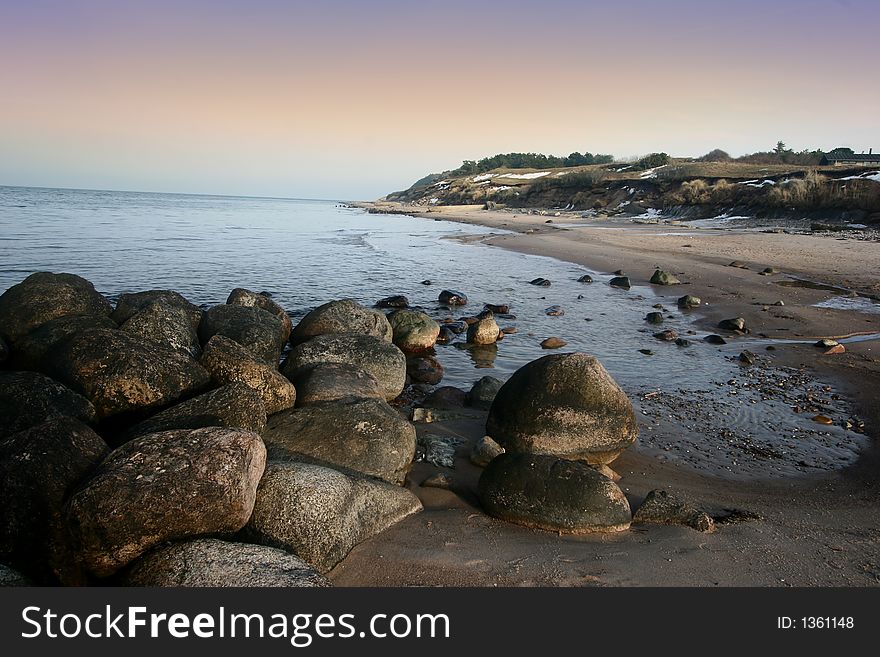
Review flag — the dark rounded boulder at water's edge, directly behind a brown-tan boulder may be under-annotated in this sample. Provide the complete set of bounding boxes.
[199,304,285,368]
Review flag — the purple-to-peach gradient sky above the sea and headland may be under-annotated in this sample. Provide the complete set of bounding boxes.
[0,0,880,200]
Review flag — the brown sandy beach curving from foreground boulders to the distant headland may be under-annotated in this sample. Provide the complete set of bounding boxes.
[330,202,880,586]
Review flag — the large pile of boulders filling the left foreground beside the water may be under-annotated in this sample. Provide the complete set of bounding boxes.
[0,273,426,586]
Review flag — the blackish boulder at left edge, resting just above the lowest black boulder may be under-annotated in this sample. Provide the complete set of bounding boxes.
[0,372,95,438]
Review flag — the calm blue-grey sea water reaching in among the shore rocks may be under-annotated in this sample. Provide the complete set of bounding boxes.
[0,187,868,474]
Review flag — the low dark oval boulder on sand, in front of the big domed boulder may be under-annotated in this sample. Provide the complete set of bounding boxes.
[478,454,632,534]
